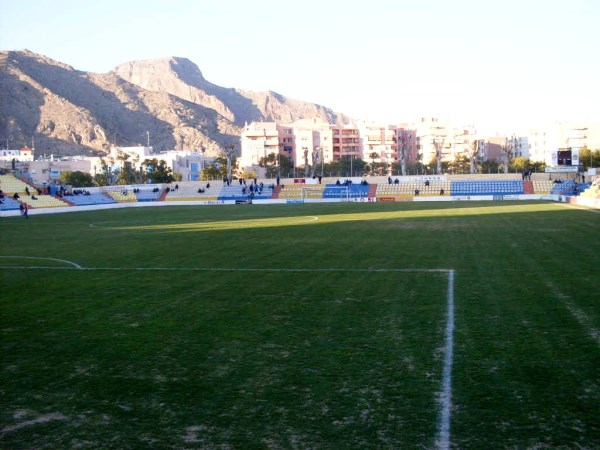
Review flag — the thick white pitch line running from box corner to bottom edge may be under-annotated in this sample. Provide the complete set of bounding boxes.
[437,270,454,450]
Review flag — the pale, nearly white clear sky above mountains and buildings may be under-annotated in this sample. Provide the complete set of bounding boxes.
[0,0,600,132]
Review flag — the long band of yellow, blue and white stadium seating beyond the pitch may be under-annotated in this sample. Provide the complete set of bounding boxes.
[0,174,600,211]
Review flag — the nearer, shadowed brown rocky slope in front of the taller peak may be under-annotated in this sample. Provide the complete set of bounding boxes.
[0,51,240,155]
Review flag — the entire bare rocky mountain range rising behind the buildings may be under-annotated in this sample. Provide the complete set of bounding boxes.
[0,50,347,156]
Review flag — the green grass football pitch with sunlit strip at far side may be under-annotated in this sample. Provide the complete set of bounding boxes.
[0,202,600,449]
